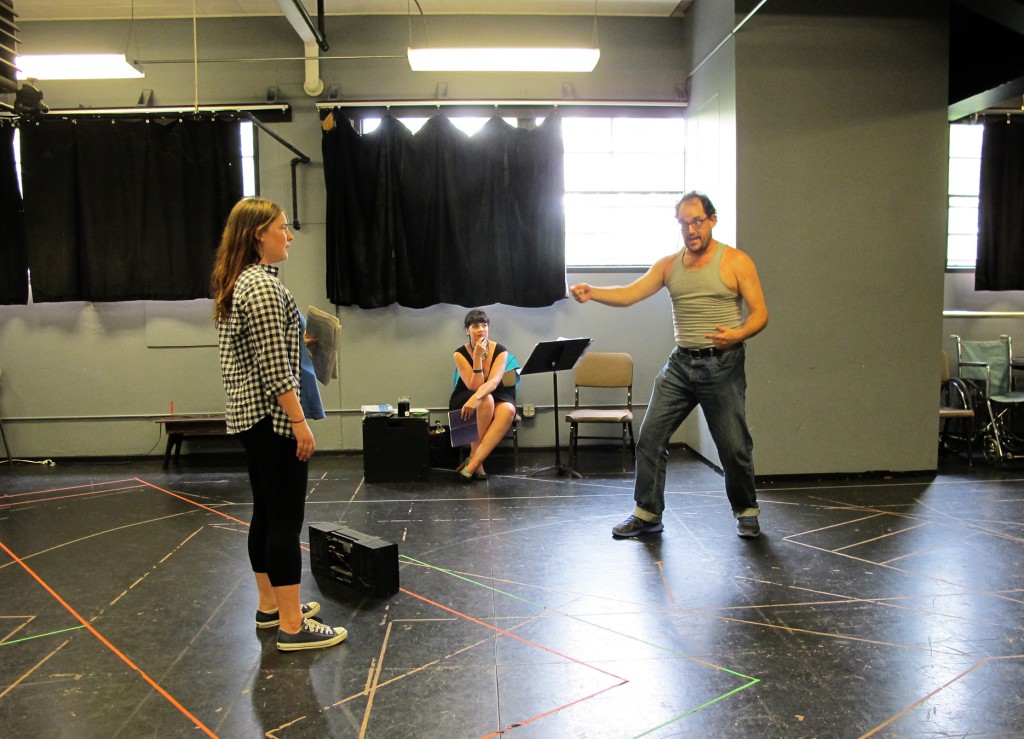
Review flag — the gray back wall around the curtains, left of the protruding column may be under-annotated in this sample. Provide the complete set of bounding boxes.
[0,16,687,458]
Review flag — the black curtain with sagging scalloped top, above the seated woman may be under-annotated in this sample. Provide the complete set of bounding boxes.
[323,108,565,308]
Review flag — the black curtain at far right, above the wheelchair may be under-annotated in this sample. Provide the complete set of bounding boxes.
[974,121,1024,290]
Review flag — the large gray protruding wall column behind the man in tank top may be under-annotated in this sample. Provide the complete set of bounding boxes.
[687,0,947,475]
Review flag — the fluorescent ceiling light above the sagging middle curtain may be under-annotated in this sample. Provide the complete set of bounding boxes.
[409,48,601,72]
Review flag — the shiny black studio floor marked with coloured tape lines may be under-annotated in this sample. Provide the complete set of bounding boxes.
[0,450,1024,739]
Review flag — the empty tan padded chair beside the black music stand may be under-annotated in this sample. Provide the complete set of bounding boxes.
[565,351,636,470]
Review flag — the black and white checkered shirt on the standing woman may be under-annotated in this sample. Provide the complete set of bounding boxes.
[217,264,299,438]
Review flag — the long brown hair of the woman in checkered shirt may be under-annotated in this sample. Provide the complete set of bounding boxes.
[210,198,285,323]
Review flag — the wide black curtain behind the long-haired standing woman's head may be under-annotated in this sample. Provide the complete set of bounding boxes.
[22,119,242,302]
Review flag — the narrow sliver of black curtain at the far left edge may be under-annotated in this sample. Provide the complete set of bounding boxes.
[0,126,29,305]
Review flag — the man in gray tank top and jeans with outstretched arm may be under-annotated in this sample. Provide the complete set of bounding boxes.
[570,191,768,538]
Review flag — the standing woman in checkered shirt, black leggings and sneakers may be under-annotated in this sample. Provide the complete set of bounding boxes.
[212,198,348,651]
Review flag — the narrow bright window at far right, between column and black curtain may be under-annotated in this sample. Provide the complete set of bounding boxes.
[946,123,984,269]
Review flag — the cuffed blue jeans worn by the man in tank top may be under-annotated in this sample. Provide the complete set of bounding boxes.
[633,346,760,521]
